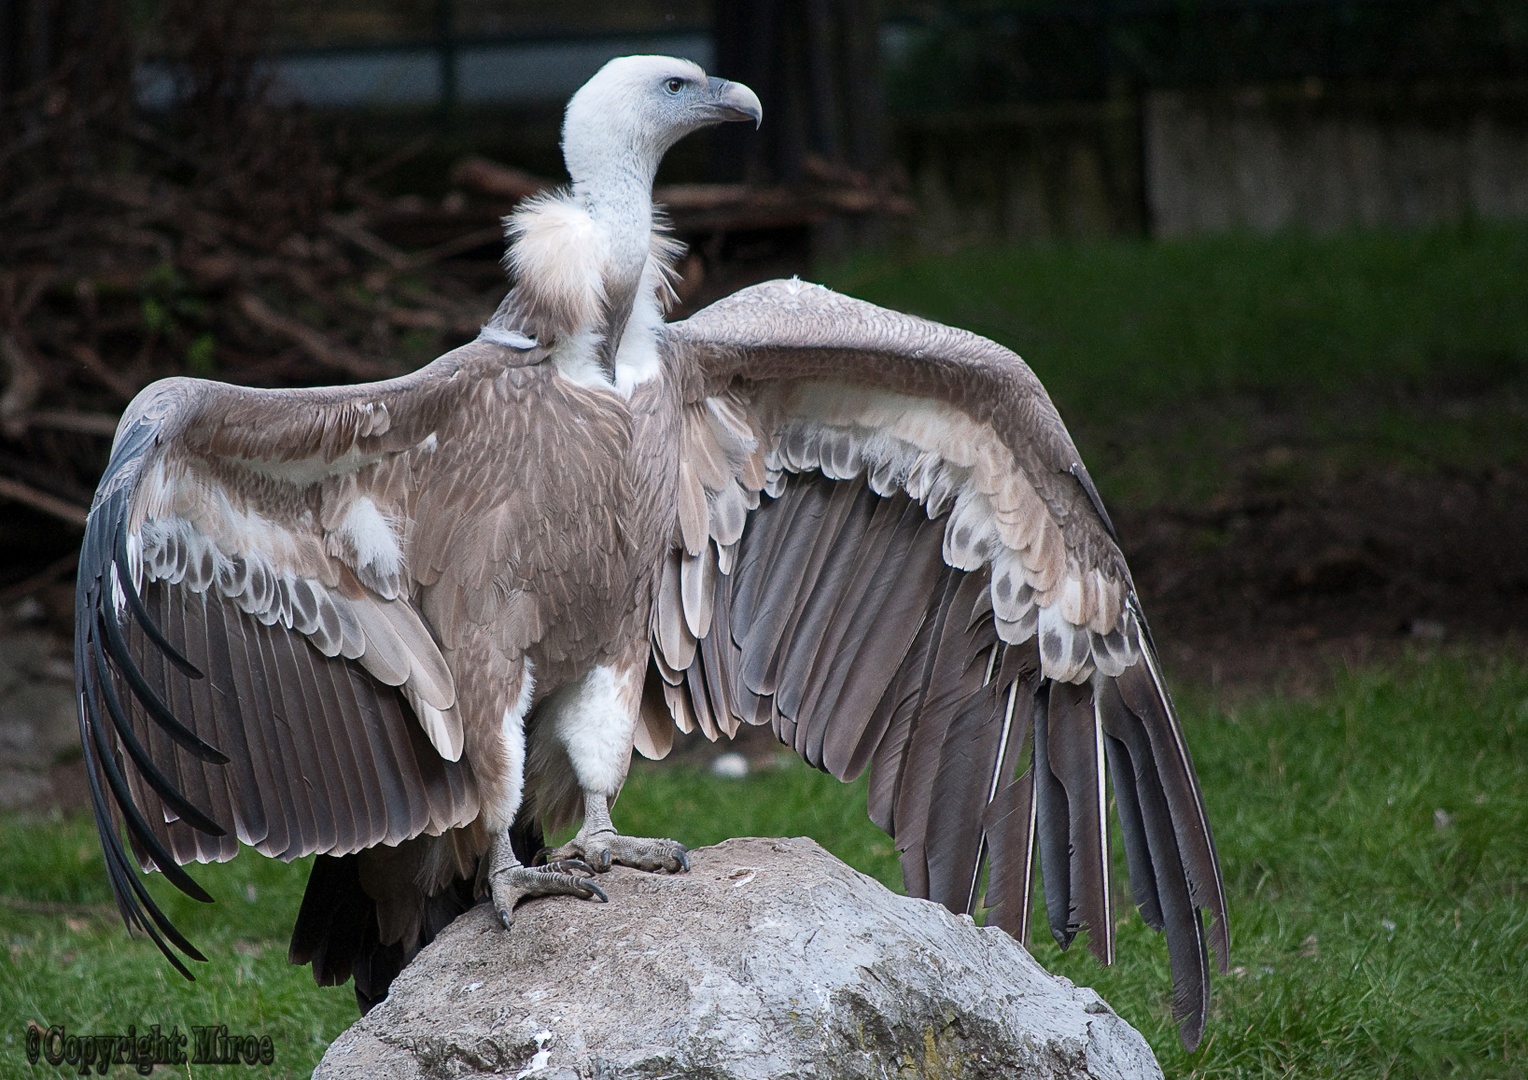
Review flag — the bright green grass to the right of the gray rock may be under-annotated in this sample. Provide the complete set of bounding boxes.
[1036,651,1528,1078]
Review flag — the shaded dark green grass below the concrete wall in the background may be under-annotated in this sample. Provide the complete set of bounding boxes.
[824,223,1528,506]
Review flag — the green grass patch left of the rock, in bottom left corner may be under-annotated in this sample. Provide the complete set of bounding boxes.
[0,814,359,1077]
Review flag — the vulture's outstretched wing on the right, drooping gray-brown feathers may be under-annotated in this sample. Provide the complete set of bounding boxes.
[657,281,1227,1045]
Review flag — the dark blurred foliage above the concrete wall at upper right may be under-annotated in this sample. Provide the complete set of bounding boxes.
[886,0,1528,112]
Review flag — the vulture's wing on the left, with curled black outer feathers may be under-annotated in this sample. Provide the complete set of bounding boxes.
[75,342,543,973]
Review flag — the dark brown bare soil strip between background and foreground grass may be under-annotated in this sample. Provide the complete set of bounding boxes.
[1115,463,1528,692]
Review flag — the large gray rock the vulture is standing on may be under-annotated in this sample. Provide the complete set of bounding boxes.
[313,839,1161,1080]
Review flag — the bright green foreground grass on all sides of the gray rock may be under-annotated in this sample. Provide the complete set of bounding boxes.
[0,651,1528,1080]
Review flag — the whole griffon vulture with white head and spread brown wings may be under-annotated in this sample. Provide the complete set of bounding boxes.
[75,57,1227,1045]
